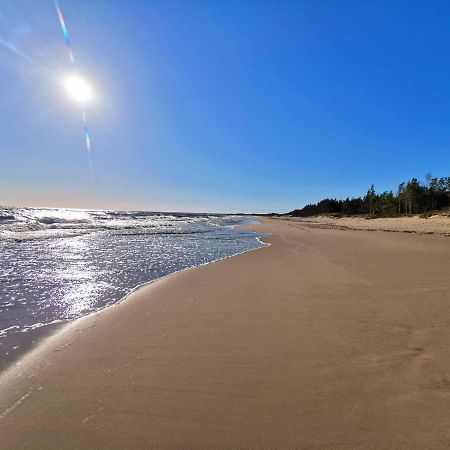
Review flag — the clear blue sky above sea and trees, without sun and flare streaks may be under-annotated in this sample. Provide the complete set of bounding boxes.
[0,0,450,212]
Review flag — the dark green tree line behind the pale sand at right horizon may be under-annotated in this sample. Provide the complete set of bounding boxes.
[288,175,450,217]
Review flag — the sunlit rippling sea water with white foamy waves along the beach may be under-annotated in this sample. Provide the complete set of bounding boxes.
[0,208,265,370]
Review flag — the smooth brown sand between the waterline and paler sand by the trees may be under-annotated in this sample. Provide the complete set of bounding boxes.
[0,220,450,449]
